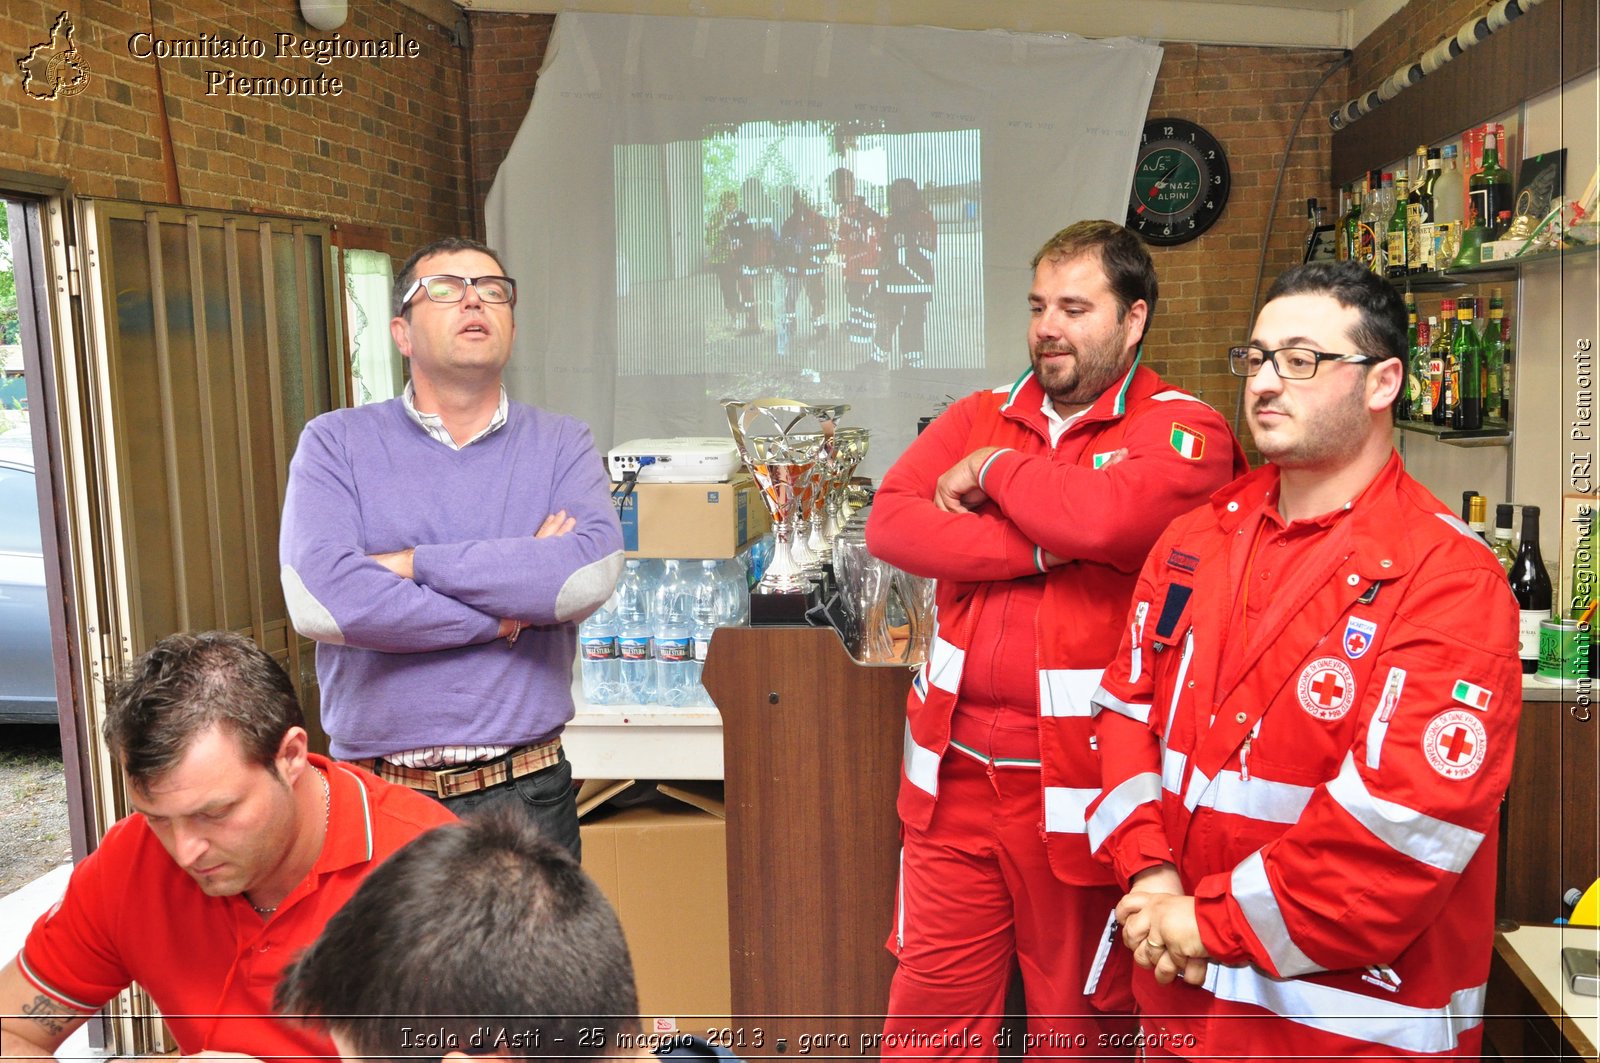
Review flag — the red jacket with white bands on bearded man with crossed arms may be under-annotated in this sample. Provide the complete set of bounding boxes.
[867,368,1245,884]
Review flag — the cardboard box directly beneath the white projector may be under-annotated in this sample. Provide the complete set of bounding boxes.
[611,475,773,559]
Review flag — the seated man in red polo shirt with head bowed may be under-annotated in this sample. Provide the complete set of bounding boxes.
[0,631,454,1060]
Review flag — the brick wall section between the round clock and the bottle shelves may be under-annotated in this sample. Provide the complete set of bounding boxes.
[1146,43,1347,443]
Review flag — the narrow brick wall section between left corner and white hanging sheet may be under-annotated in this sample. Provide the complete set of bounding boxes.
[467,13,555,235]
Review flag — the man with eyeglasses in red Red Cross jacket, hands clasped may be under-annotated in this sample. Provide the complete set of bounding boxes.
[1090,263,1522,1058]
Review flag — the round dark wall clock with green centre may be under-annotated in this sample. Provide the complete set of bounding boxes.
[1128,118,1229,245]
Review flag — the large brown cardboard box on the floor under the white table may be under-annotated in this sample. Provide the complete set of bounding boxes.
[578,780,731,1037]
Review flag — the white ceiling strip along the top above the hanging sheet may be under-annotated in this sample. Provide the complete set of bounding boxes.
[454,0,1406,48]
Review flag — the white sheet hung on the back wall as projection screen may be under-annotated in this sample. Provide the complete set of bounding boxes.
[486,13,1162,475]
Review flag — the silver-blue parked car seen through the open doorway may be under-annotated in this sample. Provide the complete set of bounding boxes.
[0,447,56,724]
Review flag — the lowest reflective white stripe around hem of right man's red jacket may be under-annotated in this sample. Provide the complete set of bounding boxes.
[1205,964,1486,1053]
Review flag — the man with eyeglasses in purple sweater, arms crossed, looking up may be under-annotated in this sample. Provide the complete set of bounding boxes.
[280,239,622,853]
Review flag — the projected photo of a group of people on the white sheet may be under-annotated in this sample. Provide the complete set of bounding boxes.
[613,120,984,375]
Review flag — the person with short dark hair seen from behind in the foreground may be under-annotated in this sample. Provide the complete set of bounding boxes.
[277,810,731,1063]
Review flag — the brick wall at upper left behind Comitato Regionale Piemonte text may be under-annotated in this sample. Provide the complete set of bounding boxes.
[0,0,474,256]
